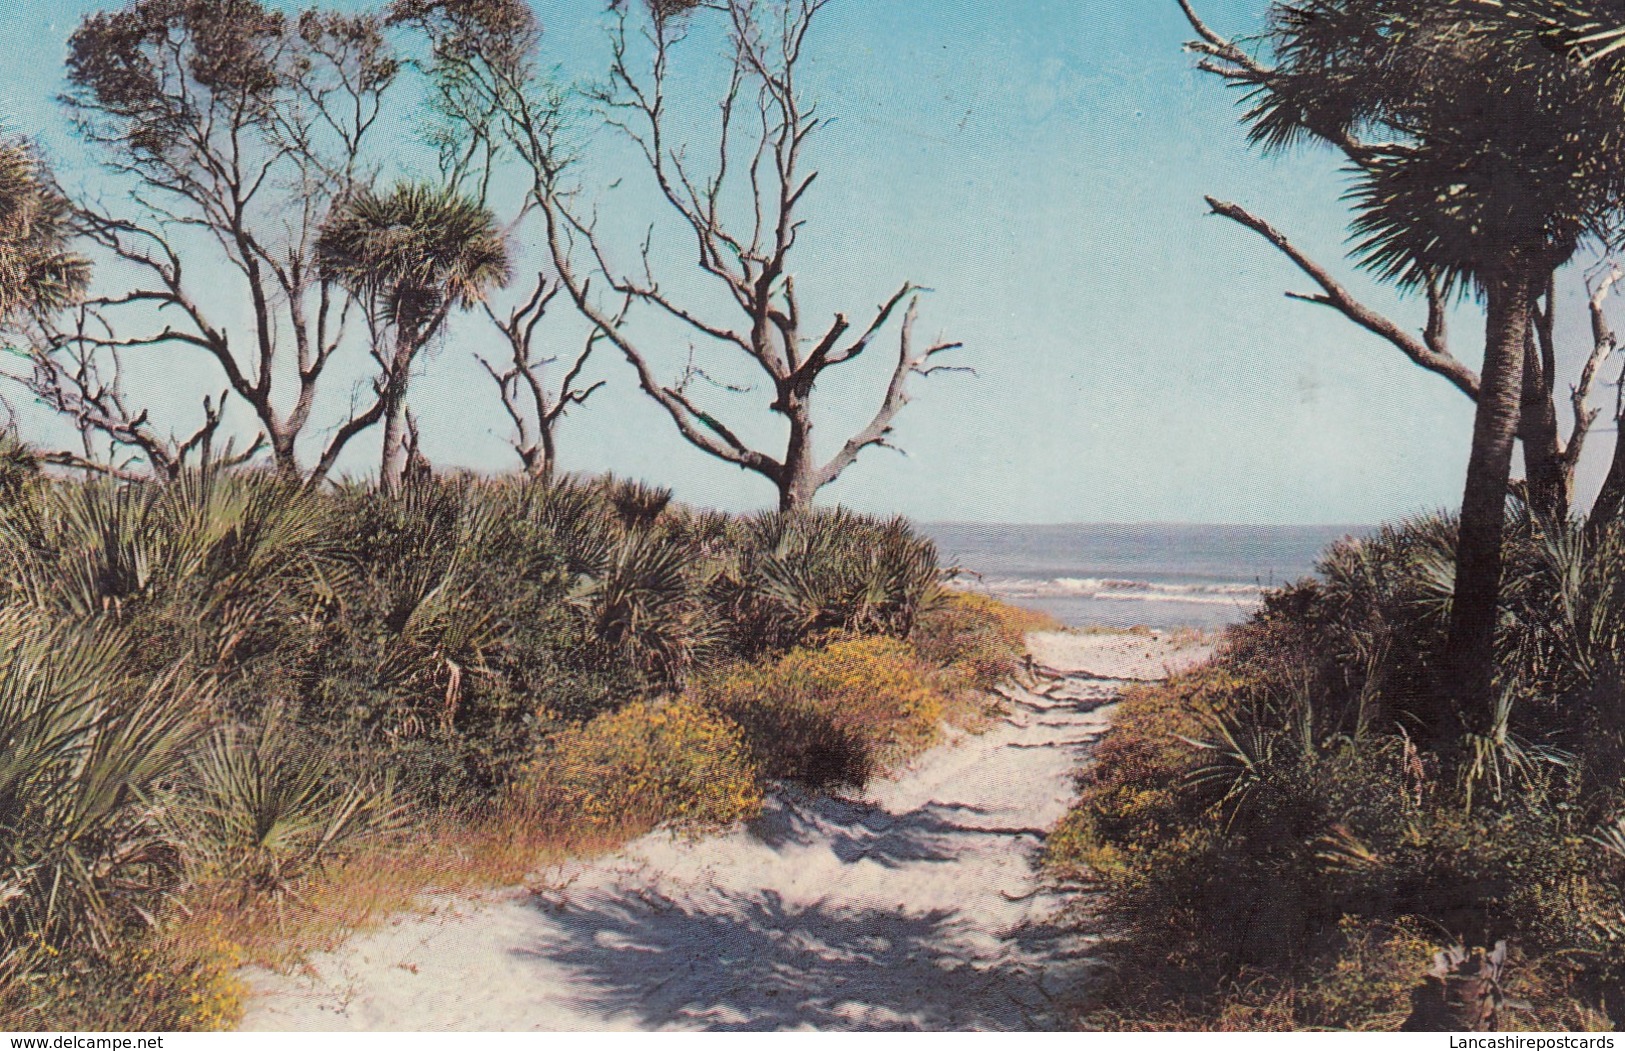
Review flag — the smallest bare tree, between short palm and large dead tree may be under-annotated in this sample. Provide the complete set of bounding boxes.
[476,275,605,479]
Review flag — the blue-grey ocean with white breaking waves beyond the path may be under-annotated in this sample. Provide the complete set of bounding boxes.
[920,523,1370,629]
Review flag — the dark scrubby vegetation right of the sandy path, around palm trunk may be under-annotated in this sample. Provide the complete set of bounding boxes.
[1048,517,1625,1030]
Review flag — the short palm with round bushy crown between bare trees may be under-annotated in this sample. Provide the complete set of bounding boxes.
[317,182,509,494]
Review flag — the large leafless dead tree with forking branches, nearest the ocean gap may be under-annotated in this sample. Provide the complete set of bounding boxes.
[416,0,960,508]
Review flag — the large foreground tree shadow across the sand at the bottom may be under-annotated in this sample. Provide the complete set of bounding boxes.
[520,892,1079,1032]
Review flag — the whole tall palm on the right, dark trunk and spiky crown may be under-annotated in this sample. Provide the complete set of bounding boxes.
[1181,0,1625,729]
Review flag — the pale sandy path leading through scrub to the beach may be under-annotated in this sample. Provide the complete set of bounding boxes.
[242,634,1203,1030]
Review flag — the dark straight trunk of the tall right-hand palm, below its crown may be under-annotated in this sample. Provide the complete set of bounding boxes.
[1432,263,1531,734]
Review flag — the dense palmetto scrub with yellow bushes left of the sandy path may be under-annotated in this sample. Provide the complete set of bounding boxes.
[0,458,1019,1028]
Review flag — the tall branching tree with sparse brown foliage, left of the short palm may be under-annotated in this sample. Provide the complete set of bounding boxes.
[57,0,398,481]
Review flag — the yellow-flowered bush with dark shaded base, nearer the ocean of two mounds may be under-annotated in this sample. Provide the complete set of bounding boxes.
[694,637,944,788]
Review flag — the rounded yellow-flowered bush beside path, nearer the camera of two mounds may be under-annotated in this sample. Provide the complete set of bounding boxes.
[523,699,762,833]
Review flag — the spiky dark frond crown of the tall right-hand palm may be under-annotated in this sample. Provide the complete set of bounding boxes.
[1246,0,1625,286]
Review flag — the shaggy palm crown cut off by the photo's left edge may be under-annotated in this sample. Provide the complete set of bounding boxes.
[0,138,89,322]
